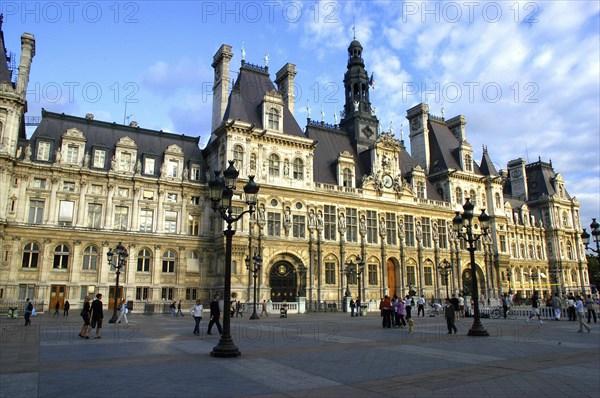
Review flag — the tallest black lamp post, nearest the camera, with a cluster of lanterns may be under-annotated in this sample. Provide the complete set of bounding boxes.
[208,160,259,358]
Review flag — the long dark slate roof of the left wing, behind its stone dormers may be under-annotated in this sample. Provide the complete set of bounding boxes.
[30,110,207,182]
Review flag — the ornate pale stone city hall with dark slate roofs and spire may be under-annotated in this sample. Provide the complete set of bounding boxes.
[0,23,589,308]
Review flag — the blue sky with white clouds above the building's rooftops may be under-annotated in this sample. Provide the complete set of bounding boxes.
[0,0,600,230]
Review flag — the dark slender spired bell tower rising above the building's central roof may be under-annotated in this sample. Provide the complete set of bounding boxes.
[340,38,379,153]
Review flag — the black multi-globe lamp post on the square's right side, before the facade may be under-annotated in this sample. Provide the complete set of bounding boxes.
[452,198,490,336]
